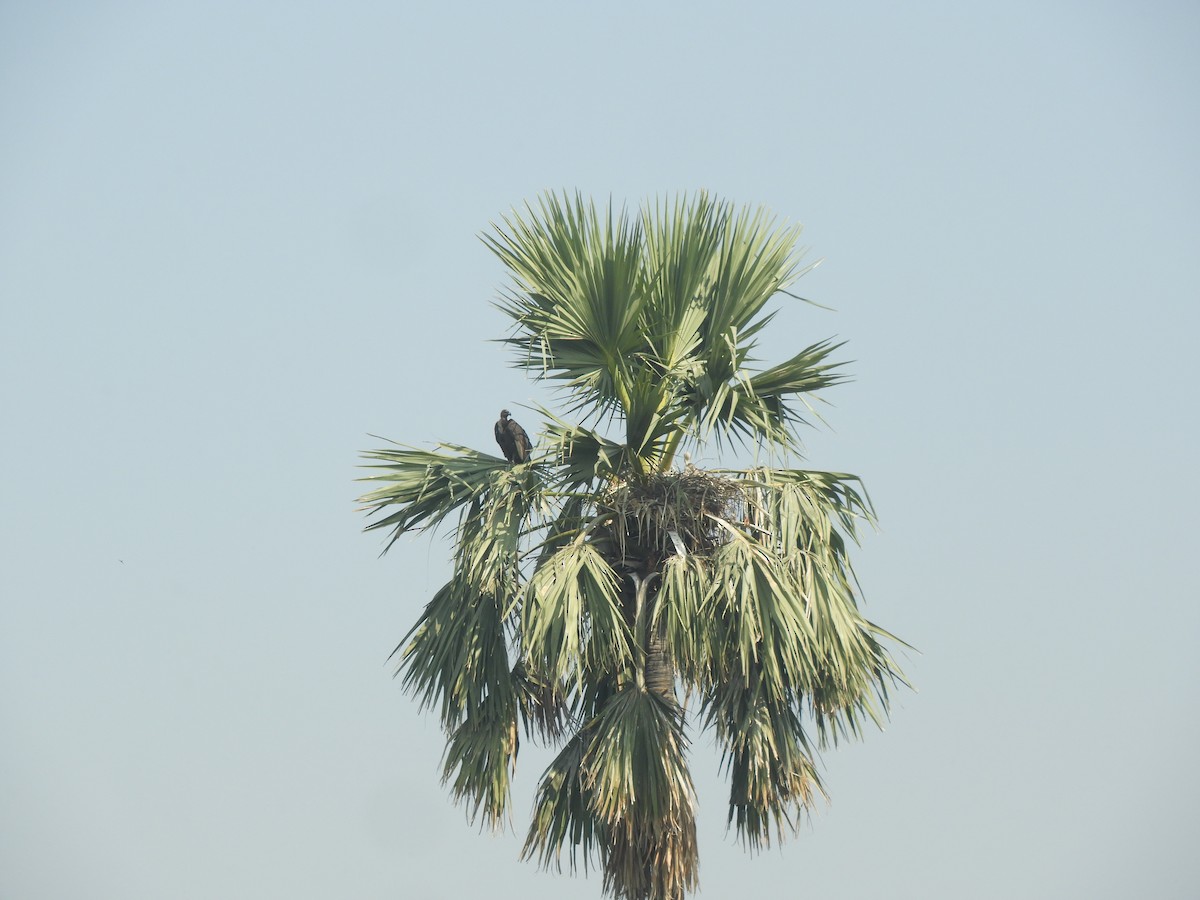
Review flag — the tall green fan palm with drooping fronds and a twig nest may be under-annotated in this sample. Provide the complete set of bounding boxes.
[361,194,902,900]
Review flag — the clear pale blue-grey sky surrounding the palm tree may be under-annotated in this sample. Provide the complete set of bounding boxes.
[0,0,1200,900]
